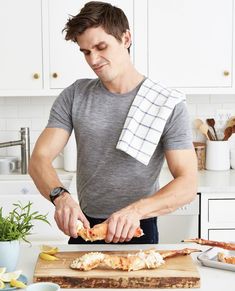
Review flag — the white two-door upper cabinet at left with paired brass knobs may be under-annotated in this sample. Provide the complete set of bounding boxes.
[0,0,134,96]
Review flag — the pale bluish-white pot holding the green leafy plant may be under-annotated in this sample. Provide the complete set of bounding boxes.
[0,240,20,272]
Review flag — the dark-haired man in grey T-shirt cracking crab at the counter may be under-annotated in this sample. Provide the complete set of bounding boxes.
[29,1,197,243]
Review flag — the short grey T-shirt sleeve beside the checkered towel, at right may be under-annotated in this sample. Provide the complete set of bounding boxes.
[161,102,193,150]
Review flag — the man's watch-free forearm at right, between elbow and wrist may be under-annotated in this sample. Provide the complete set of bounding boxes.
[128,176,197,219]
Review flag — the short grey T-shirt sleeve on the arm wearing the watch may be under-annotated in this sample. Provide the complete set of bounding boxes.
[46,85,74,134]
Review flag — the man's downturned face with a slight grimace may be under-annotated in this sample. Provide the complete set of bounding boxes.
[77,27,130,82]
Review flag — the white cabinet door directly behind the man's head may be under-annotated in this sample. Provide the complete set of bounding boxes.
[49,0,133,89]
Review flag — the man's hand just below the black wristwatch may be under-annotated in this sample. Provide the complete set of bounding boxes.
[54,193,90,238]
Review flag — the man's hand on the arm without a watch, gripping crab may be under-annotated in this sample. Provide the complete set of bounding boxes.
[105,207,141,243]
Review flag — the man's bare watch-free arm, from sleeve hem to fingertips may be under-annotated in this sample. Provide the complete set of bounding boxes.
[106,149,197,242]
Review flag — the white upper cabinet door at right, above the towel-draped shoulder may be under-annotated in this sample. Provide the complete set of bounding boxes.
[136,0,233,88]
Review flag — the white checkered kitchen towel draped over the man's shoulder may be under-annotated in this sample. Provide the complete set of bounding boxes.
[116,78,185,166]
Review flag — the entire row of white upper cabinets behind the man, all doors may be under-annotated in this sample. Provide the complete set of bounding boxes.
[0,0,235,96]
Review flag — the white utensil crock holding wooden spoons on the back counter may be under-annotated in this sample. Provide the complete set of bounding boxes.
[206,140,230,171]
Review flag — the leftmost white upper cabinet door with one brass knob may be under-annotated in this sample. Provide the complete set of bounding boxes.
[0,0,42,90]
